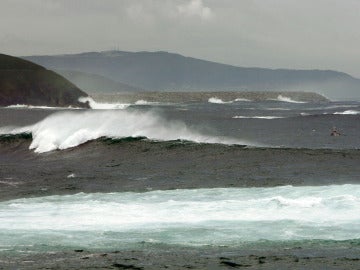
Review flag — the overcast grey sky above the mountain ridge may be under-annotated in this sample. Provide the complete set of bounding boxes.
[0,0,360,78]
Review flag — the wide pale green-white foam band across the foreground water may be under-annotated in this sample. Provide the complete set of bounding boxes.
[0,185,360,247]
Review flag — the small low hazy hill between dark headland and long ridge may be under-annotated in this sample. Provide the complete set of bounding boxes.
[55,69,144,95]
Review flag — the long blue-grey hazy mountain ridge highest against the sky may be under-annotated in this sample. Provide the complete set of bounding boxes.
[25,51,360,98]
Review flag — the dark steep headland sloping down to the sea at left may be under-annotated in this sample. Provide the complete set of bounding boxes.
[0,54,87,107]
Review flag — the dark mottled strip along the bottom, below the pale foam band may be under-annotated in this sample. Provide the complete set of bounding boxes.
[0,241,360,270]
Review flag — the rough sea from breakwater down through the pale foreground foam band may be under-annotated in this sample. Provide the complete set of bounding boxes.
[0,93,360,268]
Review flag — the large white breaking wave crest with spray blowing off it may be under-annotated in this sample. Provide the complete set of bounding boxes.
[0,110,256,153]
